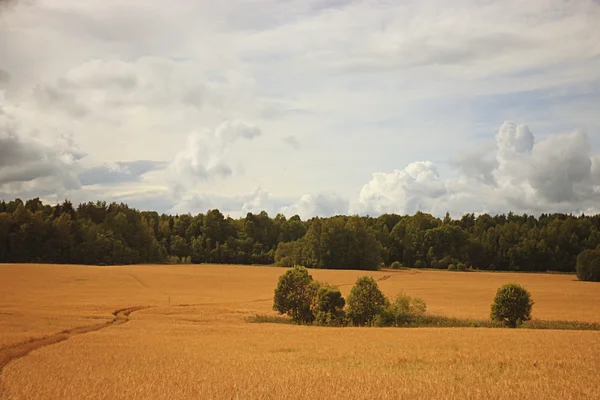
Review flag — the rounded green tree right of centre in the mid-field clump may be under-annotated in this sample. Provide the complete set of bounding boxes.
[348,276,388,326]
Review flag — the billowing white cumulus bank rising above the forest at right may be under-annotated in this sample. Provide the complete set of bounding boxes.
[353,122,600,216]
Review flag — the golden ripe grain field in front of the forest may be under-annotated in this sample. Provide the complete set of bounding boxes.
[0,265,600,399]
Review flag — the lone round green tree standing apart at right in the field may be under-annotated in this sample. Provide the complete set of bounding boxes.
[490,283,534,328]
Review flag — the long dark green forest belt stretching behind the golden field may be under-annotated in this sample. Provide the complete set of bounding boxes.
[0,198,600,271]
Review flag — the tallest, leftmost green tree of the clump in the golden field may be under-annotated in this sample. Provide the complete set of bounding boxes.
[273,265,316,324]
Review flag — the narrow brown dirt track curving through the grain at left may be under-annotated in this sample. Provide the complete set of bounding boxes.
[0,306,149,382]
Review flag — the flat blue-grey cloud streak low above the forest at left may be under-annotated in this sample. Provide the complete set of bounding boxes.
[79,160,167,186]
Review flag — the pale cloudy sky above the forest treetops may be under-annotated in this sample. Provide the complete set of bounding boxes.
[0,0,600,219]
